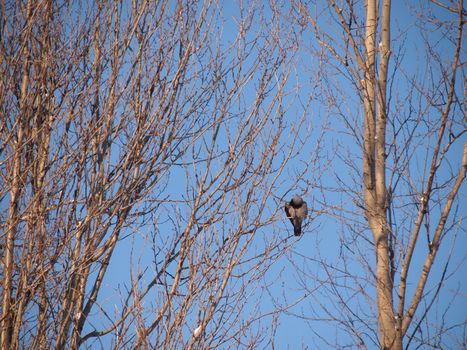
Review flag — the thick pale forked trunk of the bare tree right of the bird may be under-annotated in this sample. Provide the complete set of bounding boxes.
[362,0,402,349]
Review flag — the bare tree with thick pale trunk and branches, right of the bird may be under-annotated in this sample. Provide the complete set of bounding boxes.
[288,0,467,349]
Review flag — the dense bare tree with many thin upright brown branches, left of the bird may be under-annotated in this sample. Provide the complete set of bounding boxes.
[0,0,318,349]
